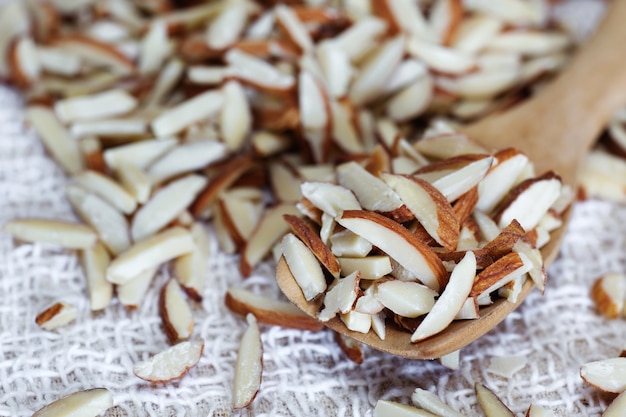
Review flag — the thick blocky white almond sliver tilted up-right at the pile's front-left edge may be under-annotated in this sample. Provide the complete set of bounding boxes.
[107,227,195,284]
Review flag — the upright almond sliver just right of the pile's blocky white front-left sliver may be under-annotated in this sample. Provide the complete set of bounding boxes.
[174,222,210,301]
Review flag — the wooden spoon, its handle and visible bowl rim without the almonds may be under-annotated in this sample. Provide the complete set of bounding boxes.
[276,0,626,359]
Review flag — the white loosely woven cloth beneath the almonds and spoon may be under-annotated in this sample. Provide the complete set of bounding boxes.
[0,1,626,417]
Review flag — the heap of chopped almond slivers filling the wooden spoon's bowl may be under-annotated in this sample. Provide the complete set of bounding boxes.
[282,133,572,342]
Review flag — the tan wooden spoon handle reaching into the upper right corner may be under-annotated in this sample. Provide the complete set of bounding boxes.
[464,0,626,184]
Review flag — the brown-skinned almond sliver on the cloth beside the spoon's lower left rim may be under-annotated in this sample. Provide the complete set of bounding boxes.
[224,288,324,331]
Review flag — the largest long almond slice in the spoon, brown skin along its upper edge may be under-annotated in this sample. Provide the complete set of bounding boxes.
[337,210,447,291]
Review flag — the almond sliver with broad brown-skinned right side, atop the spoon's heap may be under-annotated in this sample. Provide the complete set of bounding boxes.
[383,174,460,250]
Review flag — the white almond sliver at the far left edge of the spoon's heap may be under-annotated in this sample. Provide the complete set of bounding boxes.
[282,233,326,301]
